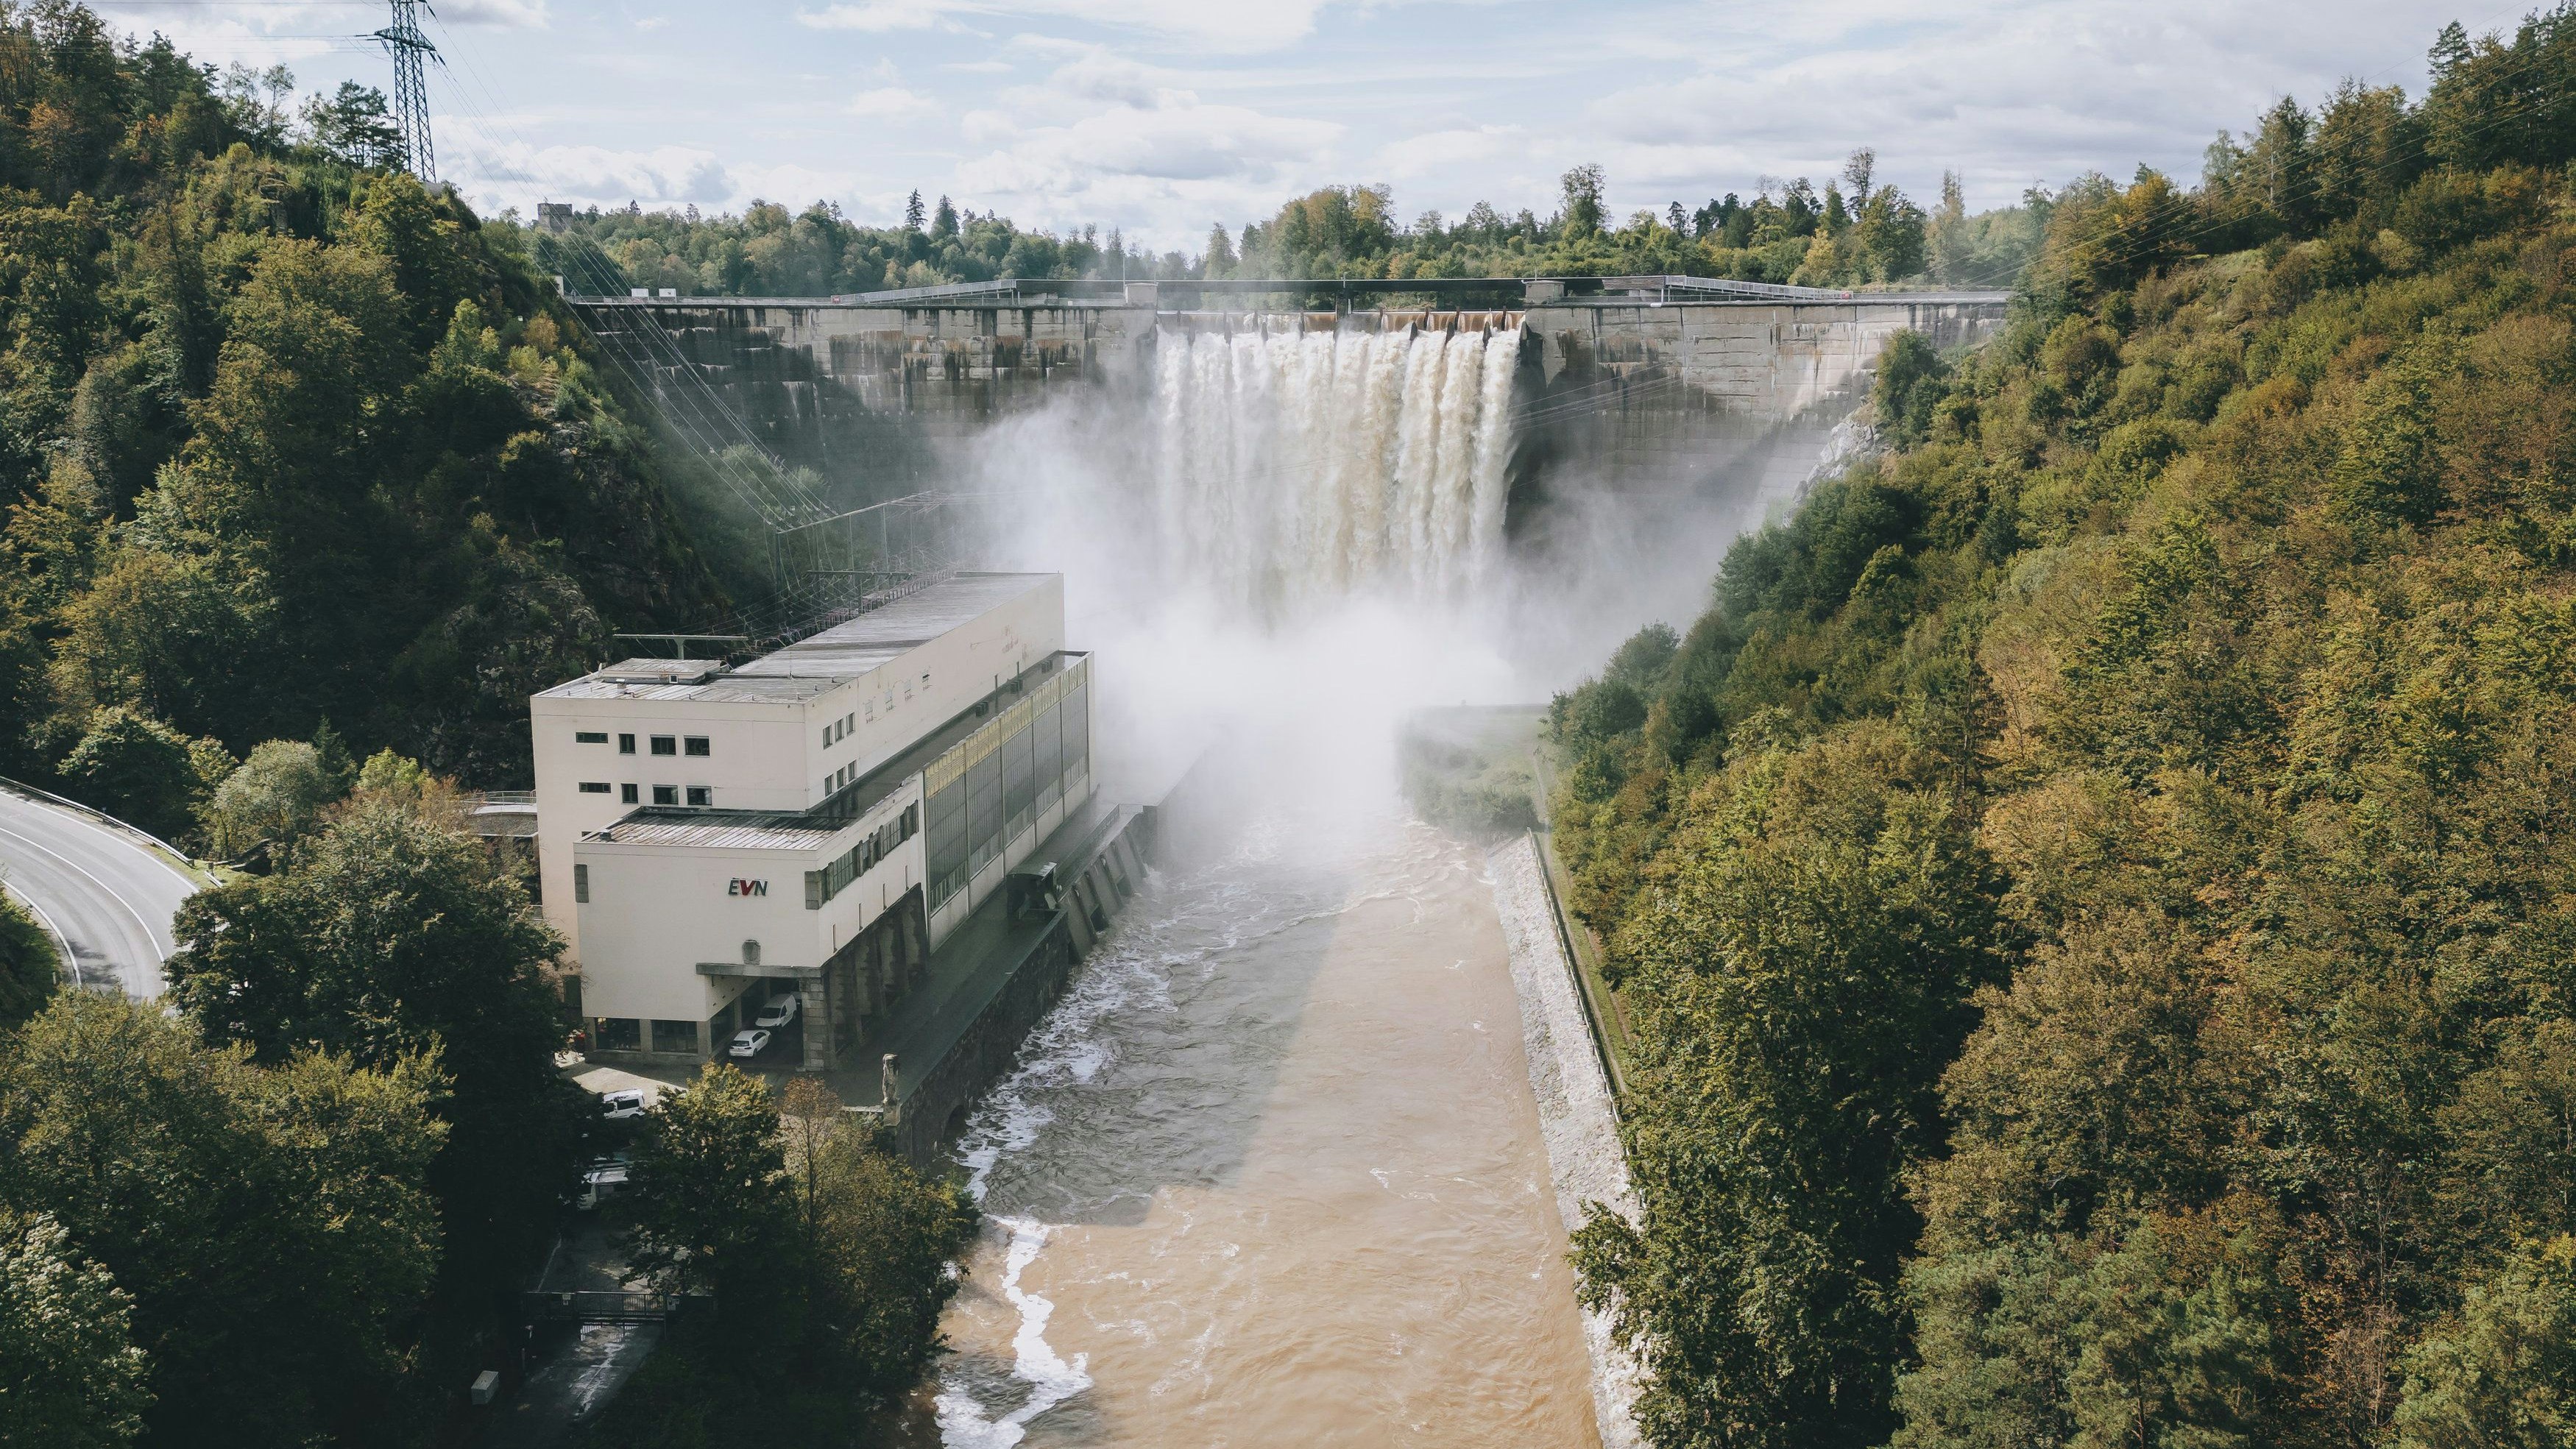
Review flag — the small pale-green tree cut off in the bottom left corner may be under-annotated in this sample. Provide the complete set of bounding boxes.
[0,1212,152,1449]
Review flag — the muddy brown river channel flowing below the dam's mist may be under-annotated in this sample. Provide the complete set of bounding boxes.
[938,801,1597,1449]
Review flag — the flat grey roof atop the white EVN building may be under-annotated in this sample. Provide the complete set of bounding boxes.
[536,574,1059,705]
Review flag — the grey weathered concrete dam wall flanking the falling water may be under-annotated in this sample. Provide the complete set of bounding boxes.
[577,294,2004,540]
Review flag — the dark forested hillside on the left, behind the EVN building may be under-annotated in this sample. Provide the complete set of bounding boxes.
[0,2,726,806]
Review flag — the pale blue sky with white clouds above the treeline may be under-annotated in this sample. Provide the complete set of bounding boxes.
[93,0,2527,252]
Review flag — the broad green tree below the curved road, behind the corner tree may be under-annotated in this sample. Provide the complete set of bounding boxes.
[0,993,443,1449]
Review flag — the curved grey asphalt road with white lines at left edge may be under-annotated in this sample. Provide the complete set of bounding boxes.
[0,787,196,999]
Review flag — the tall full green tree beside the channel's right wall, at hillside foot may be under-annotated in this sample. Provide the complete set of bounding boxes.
[1577,726,1992,1449]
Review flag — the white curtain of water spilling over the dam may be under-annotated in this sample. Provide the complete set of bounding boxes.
[1154,325,1520,617]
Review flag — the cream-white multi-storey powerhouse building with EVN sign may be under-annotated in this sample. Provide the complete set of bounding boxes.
[531,574,1092,1068]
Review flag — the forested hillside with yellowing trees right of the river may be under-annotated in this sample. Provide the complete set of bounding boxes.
[1551,7,2576,1449]
